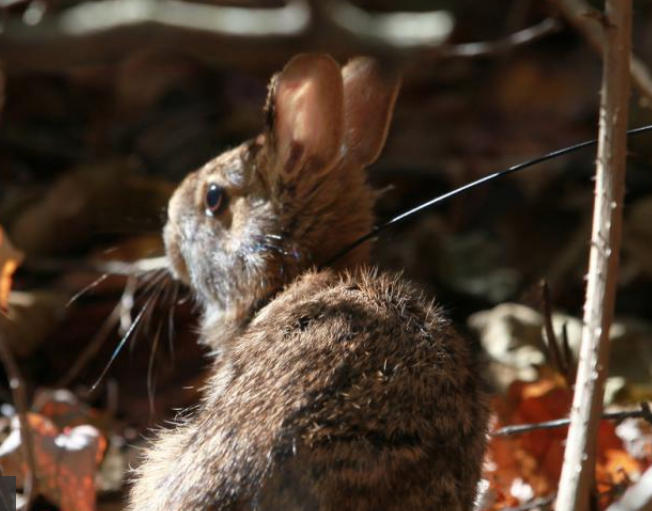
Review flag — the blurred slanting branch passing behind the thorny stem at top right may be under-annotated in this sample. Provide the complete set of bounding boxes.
[550,0,652,104]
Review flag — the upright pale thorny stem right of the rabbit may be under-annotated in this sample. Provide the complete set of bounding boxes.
[556,0,631,511]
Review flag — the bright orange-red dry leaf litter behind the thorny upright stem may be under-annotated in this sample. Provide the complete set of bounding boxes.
[485,369,648,509]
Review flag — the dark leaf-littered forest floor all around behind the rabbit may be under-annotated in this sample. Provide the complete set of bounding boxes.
[0,2,652,511]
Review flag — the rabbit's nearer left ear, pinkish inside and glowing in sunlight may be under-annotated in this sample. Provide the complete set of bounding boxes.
[267,54,344,180]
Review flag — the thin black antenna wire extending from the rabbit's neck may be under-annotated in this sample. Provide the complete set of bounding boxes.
[319,124,652,269]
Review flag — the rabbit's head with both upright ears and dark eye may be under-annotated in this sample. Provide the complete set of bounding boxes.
[164,54,398,328]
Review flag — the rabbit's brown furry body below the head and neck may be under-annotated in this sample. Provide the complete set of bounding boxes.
[132,271,487,511]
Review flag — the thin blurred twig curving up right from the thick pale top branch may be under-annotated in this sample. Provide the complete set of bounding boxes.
[439,18,560,58]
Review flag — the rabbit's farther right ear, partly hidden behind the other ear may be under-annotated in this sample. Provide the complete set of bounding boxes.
[342,57,400,165]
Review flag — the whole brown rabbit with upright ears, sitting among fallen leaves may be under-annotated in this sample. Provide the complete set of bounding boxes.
[128,54,488,511]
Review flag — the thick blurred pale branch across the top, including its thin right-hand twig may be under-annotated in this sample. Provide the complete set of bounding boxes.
[0,0,559,72]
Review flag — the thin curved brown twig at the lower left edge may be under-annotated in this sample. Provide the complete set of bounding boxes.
[0,332,36,511]
